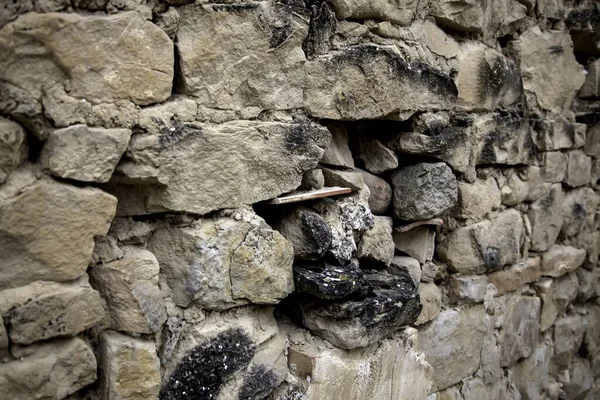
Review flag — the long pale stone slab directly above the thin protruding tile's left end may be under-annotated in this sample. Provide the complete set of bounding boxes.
[118,121,330,214]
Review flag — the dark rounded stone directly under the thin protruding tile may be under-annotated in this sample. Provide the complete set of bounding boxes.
[276,207,331,260]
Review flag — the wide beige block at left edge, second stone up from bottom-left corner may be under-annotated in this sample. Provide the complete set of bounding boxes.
[0,277,104,344]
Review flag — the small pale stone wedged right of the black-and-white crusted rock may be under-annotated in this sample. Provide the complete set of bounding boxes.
[356,216,395,265]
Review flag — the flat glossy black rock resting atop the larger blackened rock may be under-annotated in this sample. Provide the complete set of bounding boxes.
[294,260,368,300]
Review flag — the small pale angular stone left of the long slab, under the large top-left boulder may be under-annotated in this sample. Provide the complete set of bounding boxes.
[40,125,131,182]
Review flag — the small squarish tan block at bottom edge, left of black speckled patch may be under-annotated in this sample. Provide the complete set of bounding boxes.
[100,331,160,399]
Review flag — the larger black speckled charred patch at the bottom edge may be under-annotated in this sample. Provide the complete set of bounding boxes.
[159,329,256,400]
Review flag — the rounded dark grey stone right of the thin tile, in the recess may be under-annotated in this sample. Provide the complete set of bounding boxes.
[391,163,458,221]
